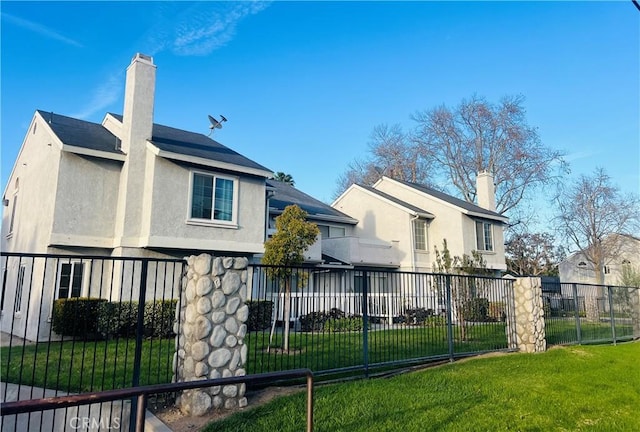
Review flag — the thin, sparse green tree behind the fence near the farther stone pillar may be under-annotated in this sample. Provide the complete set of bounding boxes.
[433,239,491,340]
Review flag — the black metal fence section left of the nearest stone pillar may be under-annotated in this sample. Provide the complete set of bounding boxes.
[0,253,185,401]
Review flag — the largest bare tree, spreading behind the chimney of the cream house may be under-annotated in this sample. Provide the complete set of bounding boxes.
[413,96,562,213]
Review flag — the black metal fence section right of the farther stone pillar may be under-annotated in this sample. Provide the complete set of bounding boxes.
[542,282,640,345]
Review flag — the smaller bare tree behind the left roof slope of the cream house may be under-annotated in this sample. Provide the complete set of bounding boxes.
[335,124,431,197]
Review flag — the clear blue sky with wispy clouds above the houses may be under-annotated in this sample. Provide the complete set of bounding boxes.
[0,1,640,211]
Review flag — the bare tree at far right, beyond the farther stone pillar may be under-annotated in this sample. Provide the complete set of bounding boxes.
[555,168,640,284]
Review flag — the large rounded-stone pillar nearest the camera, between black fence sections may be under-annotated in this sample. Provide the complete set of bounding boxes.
[173,254,249,416]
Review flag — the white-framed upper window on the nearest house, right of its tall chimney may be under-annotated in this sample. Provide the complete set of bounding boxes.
[189,172,238,224]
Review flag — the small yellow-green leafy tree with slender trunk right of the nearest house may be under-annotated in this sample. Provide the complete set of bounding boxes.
[262,205,320,351]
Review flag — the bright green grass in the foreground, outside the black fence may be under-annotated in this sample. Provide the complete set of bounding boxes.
[204,342,640,432]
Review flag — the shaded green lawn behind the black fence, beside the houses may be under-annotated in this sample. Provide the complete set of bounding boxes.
[0,323,506,392]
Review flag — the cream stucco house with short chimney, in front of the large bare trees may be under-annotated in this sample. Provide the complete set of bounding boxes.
[330,173,508,275]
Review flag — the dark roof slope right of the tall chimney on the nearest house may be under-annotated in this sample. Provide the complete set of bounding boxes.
[111,114,271,171]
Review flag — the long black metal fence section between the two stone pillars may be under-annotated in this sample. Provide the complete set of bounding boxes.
[245,265,514,375]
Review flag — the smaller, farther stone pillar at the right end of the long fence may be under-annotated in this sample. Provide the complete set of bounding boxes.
[507,278,547,352]
